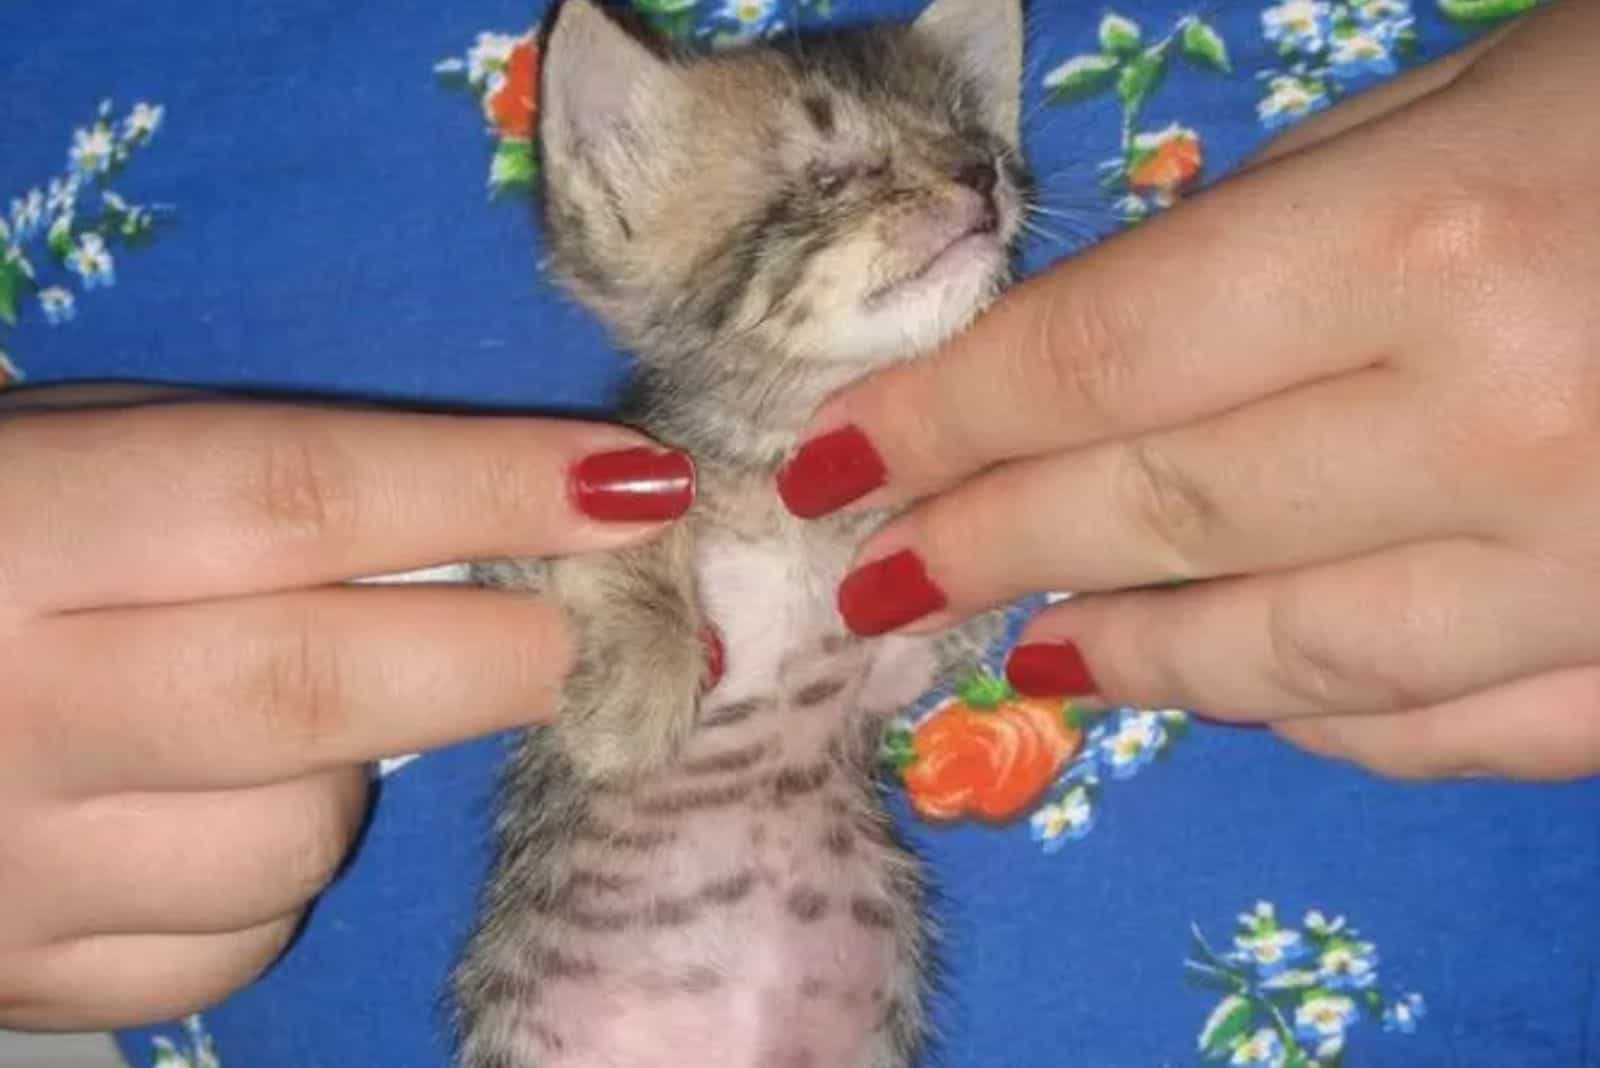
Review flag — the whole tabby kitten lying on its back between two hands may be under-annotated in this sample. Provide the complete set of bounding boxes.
[454,0,1024,1068]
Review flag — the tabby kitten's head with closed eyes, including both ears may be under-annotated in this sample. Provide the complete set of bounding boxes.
[539,0,1024,369]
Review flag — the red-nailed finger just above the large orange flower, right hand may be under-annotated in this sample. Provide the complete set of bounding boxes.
[1008,540,1600,721]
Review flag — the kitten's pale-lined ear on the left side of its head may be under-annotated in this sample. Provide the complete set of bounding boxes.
[539,0,683,152]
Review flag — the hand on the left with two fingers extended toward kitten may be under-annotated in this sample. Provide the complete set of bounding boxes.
[0,403,693,1030]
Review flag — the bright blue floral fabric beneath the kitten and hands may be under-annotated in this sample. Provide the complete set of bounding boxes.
[0,0,1600,1068]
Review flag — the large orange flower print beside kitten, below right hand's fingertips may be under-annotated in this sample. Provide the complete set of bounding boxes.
[898,676,1083,823]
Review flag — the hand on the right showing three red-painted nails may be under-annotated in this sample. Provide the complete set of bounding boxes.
[779,3,1600,779]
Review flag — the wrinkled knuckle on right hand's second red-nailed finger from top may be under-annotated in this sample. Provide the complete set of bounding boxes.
[1118,440,1221,579]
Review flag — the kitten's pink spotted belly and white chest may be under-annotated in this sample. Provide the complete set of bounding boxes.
[528,544,918,1068]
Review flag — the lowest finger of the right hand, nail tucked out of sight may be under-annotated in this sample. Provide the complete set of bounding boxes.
[1272,668,1600,780]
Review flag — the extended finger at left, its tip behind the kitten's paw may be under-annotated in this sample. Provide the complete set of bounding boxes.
[14,587,571,796]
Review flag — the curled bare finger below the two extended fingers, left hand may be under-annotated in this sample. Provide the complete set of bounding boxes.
[0,769,368,938]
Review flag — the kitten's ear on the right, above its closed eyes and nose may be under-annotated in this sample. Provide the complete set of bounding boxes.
[912,0,1022,141]
